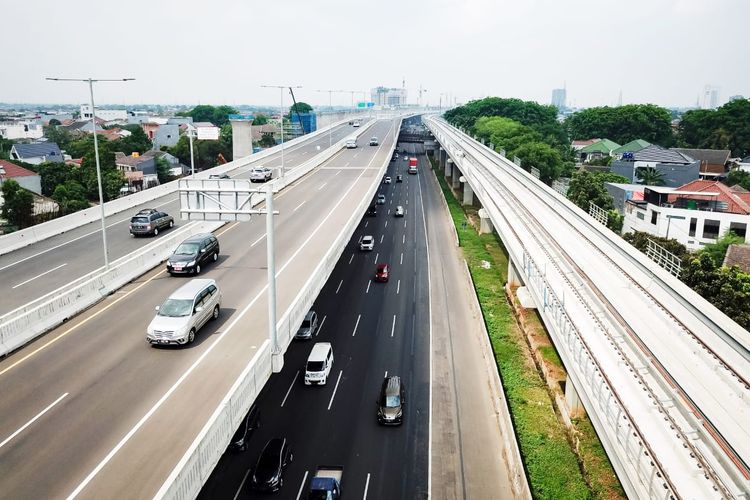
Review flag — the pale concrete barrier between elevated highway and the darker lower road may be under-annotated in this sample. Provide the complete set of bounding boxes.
[154,120,401,500]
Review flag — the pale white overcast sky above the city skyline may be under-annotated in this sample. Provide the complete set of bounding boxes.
[0,0,750,107]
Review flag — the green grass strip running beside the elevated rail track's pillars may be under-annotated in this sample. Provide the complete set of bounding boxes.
[428,157,624,499]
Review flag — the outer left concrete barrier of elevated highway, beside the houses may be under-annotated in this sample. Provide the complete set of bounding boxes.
[0,119,360,255]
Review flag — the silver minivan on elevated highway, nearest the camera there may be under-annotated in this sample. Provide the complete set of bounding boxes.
[146,279,221,345]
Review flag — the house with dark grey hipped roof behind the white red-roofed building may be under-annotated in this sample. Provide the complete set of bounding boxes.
[610,144,700,187]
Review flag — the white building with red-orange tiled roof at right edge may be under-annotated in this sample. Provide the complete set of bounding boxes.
[623,180,750,250]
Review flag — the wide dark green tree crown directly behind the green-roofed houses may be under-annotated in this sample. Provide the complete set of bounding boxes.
[565,104,674,146]
